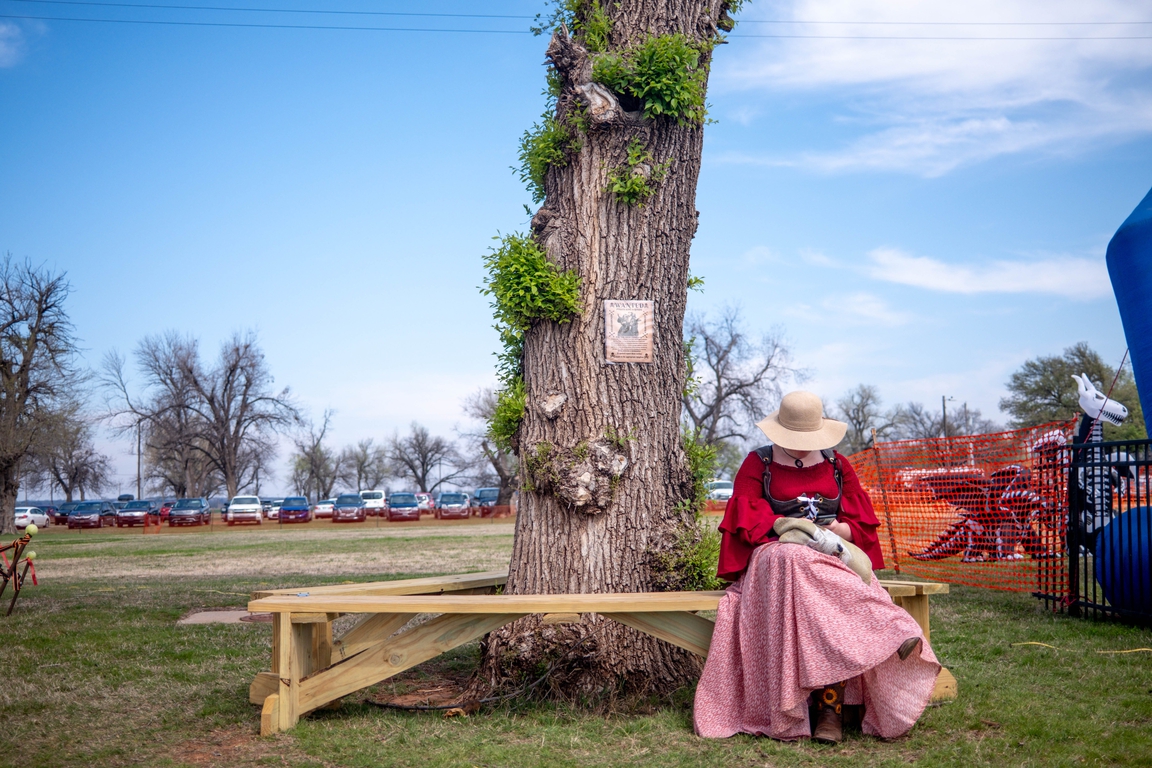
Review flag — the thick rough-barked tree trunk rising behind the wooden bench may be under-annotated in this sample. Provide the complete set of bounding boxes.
[480,0,723,695]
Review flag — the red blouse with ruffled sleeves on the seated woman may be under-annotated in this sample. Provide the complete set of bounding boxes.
[718,453,884,581]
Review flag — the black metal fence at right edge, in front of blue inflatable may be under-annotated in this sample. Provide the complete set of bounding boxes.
[1059,440,1152,624]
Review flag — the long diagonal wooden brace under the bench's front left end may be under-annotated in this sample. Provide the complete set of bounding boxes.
[297,614,524,723]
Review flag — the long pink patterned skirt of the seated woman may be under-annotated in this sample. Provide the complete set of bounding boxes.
[694,542,940,740]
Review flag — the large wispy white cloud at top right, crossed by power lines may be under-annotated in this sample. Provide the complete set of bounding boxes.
[713,0,1152,176]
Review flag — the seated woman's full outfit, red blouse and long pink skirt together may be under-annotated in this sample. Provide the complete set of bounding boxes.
[692,454,940,739]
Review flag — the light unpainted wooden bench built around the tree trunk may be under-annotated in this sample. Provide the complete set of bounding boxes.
[248,571,956,736]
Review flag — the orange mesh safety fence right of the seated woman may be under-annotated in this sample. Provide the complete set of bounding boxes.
[848,420,1076,596]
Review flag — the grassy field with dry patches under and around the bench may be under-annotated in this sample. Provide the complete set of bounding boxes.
[0,525,1152,768]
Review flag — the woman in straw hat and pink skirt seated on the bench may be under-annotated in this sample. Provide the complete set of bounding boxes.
[694,391,940,743]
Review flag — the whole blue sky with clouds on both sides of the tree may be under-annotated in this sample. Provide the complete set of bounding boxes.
[0,0,1152,486]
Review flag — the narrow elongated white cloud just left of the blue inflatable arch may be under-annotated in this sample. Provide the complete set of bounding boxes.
[867,248,1112,299]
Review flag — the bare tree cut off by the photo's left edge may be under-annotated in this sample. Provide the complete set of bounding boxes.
[0,254,77,534]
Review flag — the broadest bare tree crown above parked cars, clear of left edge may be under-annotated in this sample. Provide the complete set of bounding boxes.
[101,333,297,496]
